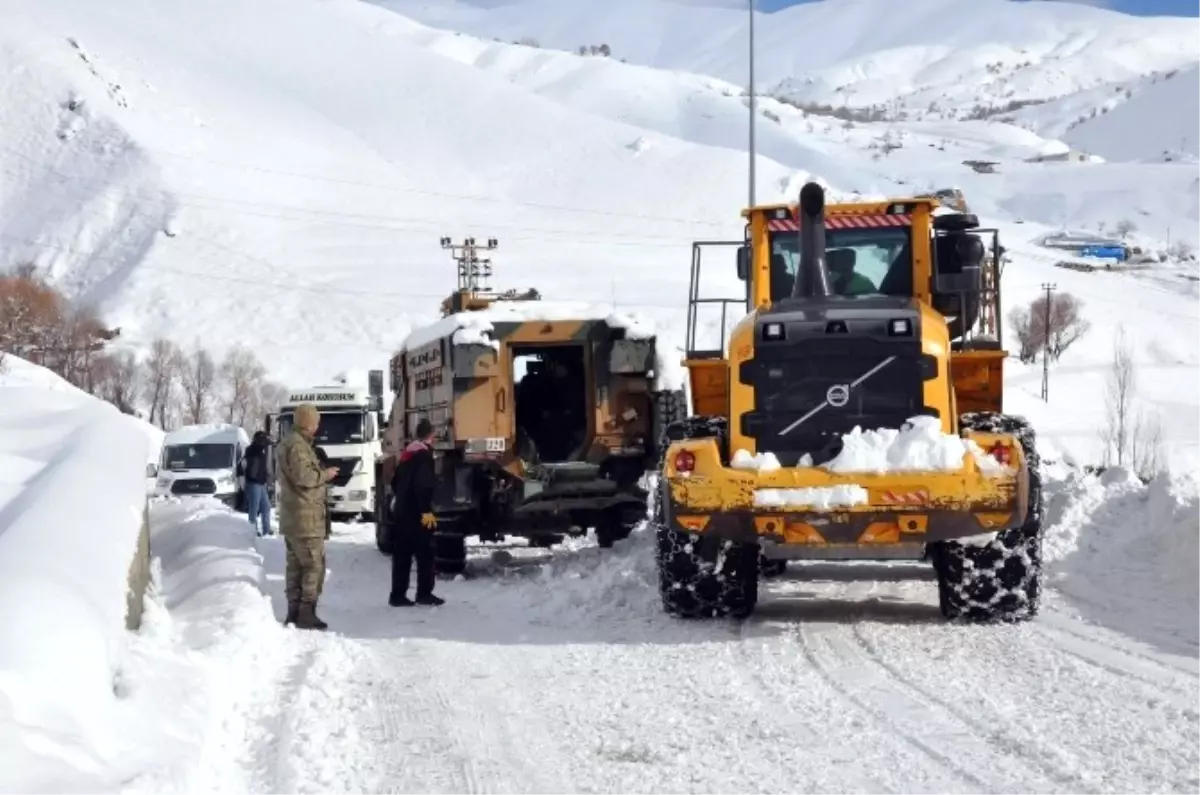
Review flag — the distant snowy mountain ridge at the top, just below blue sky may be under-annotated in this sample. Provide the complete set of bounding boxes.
[377,0,1200,118]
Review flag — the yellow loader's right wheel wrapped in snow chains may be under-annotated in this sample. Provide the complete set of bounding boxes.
[930,412,1042,622]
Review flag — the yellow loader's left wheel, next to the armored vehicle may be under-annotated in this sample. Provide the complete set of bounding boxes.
[650,417,758,618]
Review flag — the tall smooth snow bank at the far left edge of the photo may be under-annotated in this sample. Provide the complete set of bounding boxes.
[0,357,160,791]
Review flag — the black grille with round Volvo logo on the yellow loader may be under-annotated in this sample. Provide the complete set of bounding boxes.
[742,337,937,466]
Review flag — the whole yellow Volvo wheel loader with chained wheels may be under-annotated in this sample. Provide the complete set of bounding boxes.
[652,183,1042,621]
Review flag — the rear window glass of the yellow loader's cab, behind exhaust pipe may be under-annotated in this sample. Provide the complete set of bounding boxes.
[770,228,912,301]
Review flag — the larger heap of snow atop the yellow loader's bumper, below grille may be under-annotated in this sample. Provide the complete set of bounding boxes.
[822,417,1004,474]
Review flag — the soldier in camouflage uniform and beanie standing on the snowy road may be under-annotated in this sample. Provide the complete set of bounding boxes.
[277,404,337,629]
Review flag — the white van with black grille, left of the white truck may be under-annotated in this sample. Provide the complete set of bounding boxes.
[148,423,250,510]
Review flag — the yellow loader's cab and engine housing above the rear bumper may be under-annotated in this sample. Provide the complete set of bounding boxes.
[685,185,1006,450]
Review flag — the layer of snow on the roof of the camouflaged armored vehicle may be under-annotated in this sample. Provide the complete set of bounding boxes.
[400,300,654,351]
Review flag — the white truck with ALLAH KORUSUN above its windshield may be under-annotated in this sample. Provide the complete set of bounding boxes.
[268,370,383,519]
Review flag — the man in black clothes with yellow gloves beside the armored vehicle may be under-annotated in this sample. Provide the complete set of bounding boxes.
[388,419,444,608]
